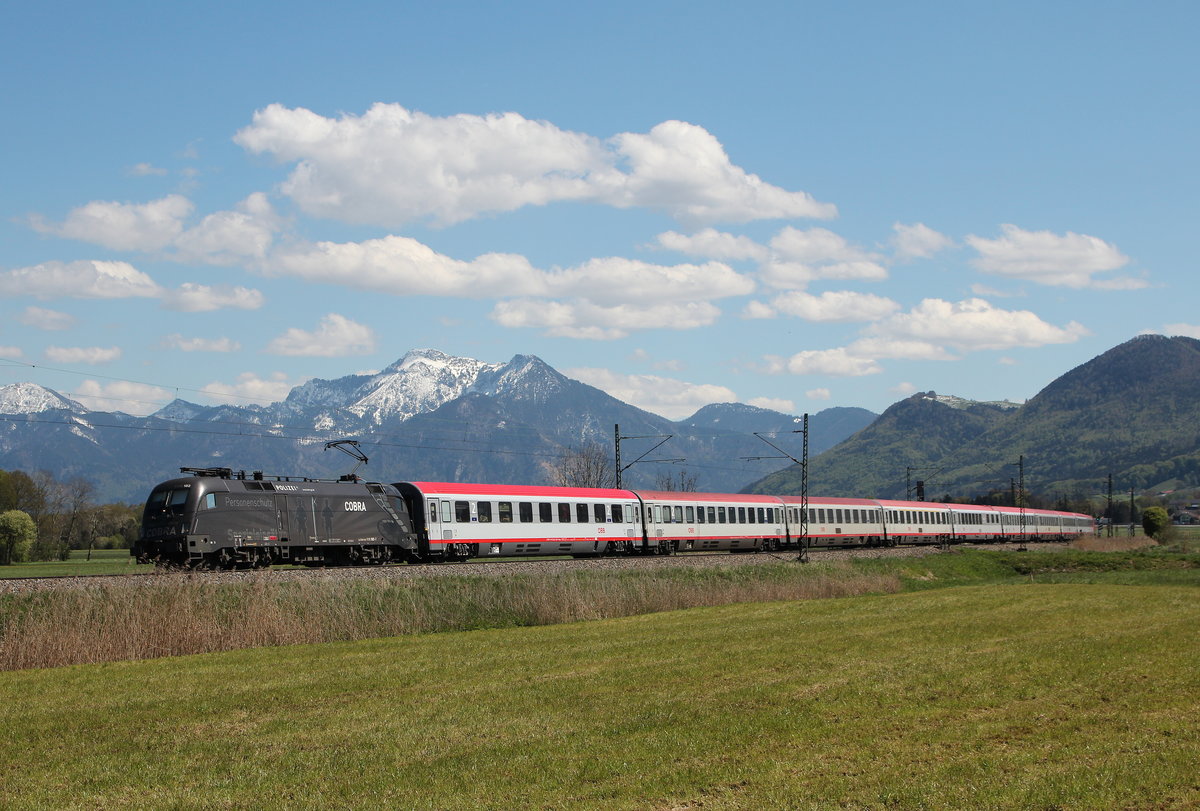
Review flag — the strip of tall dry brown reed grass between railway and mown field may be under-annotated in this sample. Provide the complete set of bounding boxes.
[0,566,900,669]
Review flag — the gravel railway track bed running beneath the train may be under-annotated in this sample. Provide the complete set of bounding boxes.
[0,542,1067,595]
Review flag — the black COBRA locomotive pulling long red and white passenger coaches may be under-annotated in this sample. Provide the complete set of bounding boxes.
[131,468,1096,569]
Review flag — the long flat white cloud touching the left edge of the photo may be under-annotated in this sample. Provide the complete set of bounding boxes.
[0,259,162,299]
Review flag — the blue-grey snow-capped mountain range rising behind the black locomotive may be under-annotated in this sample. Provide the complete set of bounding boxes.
[0,349,873,501]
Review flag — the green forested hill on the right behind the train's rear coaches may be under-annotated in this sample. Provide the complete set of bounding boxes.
[751,335,1200,498]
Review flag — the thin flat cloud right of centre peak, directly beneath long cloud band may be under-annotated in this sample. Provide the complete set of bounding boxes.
[491,299,721,341]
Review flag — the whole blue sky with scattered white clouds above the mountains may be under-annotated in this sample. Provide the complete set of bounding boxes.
[0,6,1200,419]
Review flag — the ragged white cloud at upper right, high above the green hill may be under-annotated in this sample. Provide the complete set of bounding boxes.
[966,224,1147,289]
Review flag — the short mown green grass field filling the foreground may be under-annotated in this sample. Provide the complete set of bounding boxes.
[0,580,1200,809]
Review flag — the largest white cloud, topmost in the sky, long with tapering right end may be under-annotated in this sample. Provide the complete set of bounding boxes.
[234,103,836,227]
